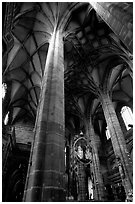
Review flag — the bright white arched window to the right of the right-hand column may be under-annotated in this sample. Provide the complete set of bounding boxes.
[121,106,133,130]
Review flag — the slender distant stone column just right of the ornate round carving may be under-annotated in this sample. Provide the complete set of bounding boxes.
[87,117,104,201]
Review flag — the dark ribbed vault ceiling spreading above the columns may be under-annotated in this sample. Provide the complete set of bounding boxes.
[3,2,132,128]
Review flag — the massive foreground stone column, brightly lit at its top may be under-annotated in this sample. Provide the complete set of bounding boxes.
[24,30,65,202]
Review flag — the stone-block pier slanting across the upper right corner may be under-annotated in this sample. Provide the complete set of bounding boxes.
[90,2,133,53]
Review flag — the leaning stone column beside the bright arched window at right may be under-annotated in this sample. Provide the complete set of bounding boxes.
[100,92,133,193]
